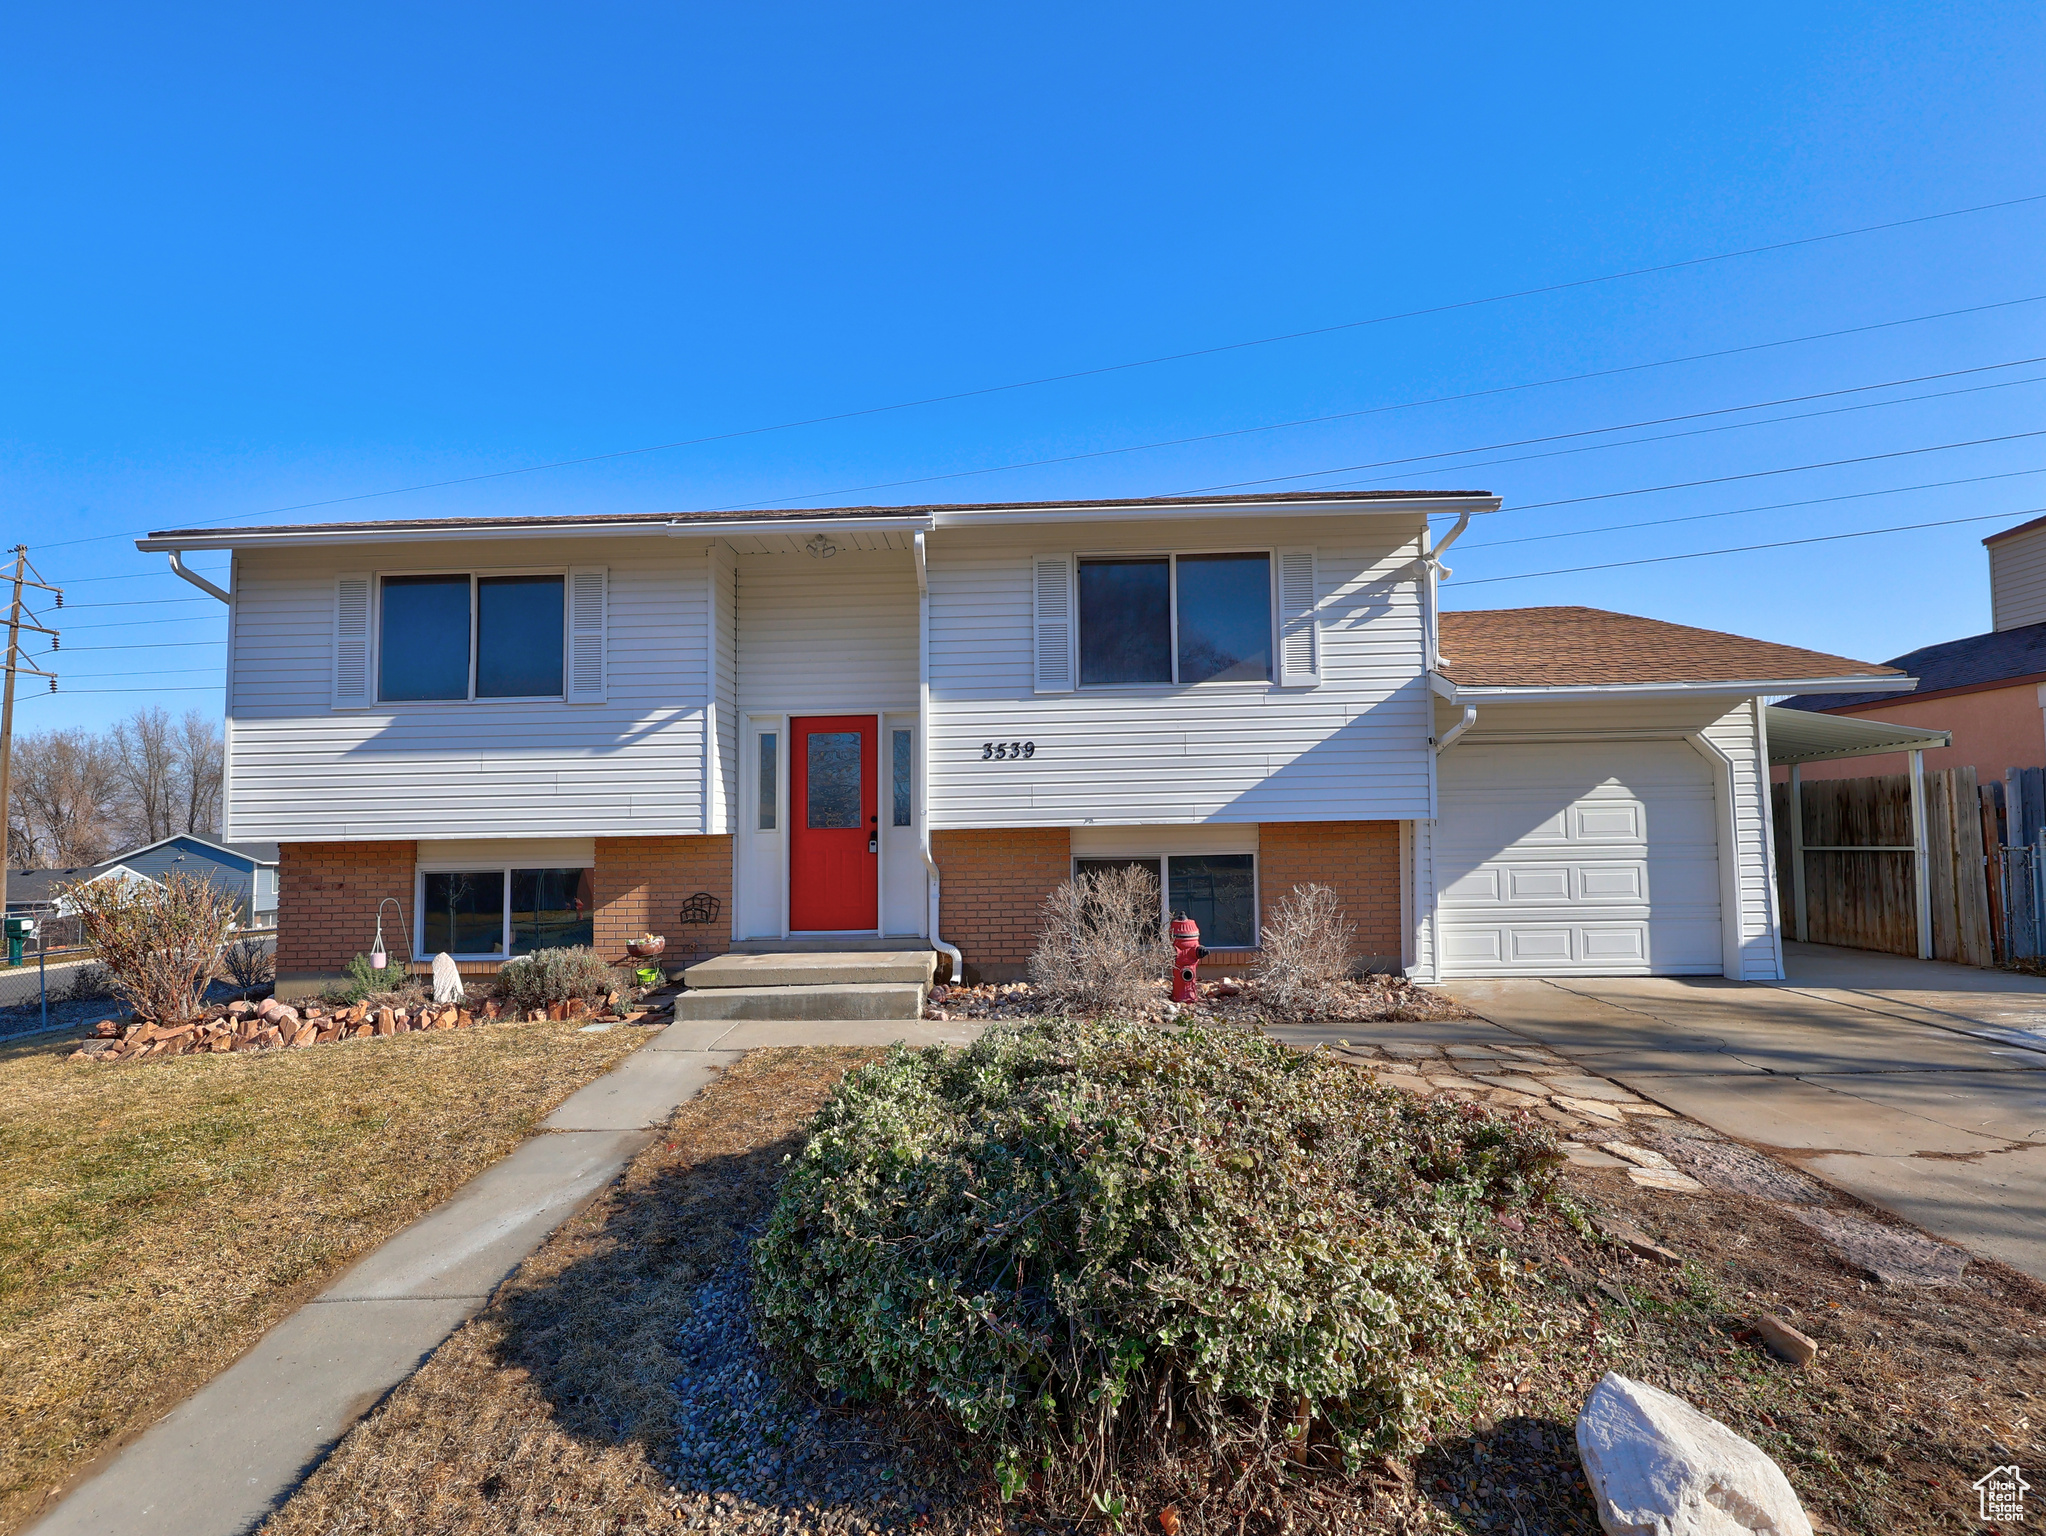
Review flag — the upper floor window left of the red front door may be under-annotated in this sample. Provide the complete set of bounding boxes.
[376,575,567,702]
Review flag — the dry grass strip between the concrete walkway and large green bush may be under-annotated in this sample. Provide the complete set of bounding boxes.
[264,1047,876,1536]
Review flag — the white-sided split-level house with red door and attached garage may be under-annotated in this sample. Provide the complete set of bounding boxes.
[139,491,1911,990]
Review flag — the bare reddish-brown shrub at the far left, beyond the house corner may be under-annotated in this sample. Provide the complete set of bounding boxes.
[59,875,237,1023]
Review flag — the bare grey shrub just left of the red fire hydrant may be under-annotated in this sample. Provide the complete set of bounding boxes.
[1029,863,1172,1014]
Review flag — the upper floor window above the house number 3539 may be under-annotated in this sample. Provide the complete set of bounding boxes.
[1078,552,1273,687]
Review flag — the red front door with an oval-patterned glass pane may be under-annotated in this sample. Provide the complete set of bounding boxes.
[788,714,882,933]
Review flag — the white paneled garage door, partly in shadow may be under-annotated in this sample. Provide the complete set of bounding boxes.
[1434,740,1725,976]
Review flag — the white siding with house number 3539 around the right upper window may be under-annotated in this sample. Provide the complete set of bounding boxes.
[931,513,1430,828]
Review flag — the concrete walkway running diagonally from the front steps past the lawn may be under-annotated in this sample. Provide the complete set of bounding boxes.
[29,1021,978,1536]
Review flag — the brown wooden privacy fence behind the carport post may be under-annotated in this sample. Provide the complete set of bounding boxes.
[1770,767,1997,965]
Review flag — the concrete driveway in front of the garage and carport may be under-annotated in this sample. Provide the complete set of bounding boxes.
[1444,945,2046,1280]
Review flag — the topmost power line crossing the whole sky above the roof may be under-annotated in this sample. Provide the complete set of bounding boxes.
[19,192,2046,548]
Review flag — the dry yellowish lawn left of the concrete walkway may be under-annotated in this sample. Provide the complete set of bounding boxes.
[0,1025,644,1532]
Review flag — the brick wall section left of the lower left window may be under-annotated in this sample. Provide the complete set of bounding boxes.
[276,843,417,982]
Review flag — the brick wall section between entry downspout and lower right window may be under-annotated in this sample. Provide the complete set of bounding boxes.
[931,826,1072,982]
